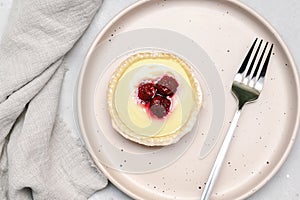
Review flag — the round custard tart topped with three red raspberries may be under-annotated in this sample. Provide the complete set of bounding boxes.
[107,51,202,146]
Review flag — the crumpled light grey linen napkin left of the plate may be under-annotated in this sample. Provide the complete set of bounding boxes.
[0,0,107,200]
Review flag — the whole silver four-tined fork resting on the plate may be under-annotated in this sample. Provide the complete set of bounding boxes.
[201,38,273,200]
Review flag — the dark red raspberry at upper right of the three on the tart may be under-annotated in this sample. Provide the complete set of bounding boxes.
[155,75,178,96]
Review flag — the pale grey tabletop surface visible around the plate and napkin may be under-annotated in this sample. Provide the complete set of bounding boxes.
[0,0,300,200]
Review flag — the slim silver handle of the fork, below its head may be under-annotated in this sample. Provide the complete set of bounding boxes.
[201,109,242,200]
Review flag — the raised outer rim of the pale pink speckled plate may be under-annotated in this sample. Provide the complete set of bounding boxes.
[74,0,300,199]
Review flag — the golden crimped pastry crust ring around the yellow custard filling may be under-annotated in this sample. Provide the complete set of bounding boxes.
[107,52,202,146]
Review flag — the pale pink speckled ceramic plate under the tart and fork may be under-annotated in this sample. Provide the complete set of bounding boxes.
[77,0,299,200]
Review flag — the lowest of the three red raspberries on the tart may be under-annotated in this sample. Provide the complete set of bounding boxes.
[150,96,171,118]
